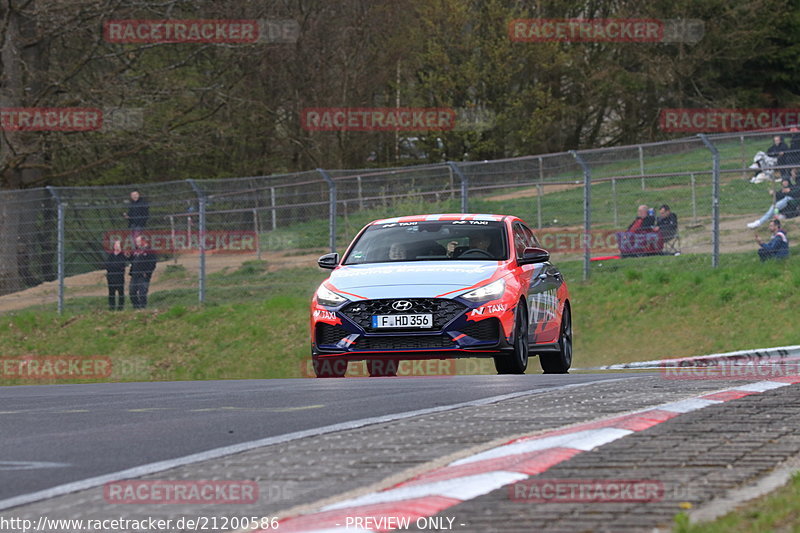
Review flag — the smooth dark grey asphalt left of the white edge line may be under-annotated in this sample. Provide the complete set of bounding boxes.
[0,373,631,501]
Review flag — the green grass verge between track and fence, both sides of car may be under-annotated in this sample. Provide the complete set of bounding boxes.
[0,250,800,383]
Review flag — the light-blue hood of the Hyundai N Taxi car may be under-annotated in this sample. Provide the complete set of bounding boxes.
[328,261,500,299]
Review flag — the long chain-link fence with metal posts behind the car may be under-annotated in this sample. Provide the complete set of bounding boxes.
[0,129,800,312]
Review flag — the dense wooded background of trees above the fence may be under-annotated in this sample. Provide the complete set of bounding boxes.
[0,0,800,189]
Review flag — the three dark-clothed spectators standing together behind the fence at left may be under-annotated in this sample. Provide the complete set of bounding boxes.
[105,191,156,311]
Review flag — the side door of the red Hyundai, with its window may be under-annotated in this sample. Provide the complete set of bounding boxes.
[514,223,564,344]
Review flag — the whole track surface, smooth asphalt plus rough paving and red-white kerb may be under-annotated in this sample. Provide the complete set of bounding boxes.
[0,372,800,532]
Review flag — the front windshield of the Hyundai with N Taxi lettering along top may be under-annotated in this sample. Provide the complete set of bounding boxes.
[343,220,508,265]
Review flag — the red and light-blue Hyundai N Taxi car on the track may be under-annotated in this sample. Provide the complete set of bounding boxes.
[311,214,572,377]
